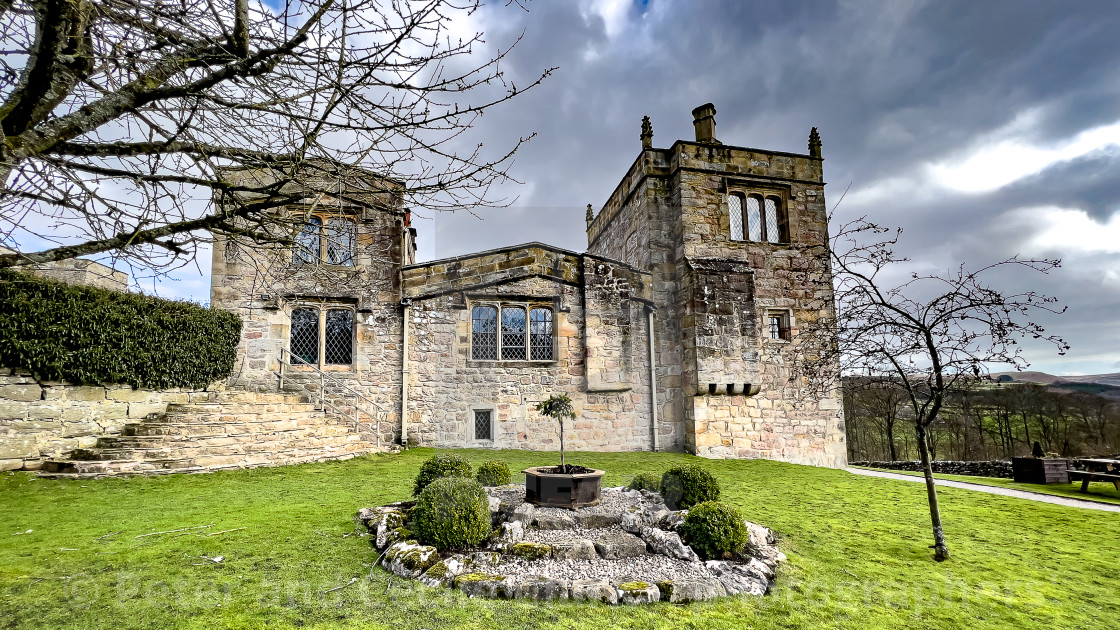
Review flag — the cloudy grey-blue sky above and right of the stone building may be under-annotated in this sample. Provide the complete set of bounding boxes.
[159,0,1120,374]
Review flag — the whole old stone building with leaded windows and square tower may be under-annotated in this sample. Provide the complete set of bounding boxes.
[212,104,846,466]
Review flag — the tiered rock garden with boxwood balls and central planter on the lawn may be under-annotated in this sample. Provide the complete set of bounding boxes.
[358,455,784,604]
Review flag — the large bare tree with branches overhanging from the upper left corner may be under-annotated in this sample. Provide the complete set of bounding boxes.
[0,0,551,272]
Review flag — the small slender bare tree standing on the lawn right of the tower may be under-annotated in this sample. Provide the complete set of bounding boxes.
[794,219,1068,560]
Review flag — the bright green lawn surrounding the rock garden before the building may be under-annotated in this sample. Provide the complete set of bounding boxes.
[0,450,1120,630]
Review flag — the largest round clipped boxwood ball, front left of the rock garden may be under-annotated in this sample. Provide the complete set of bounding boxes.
[412,476,491,550]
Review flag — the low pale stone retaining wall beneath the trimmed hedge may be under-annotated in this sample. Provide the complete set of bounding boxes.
[0,368,206,471]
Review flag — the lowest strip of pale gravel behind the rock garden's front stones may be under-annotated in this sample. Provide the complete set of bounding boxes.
[496,555,713,584]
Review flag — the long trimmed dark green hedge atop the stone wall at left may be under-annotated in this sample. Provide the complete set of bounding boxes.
[0,269,241,389]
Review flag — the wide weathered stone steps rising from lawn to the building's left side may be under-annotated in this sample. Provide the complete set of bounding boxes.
[40,383,376,479]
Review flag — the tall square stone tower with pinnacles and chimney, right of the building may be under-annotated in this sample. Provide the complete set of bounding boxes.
[587,103,846,466]
